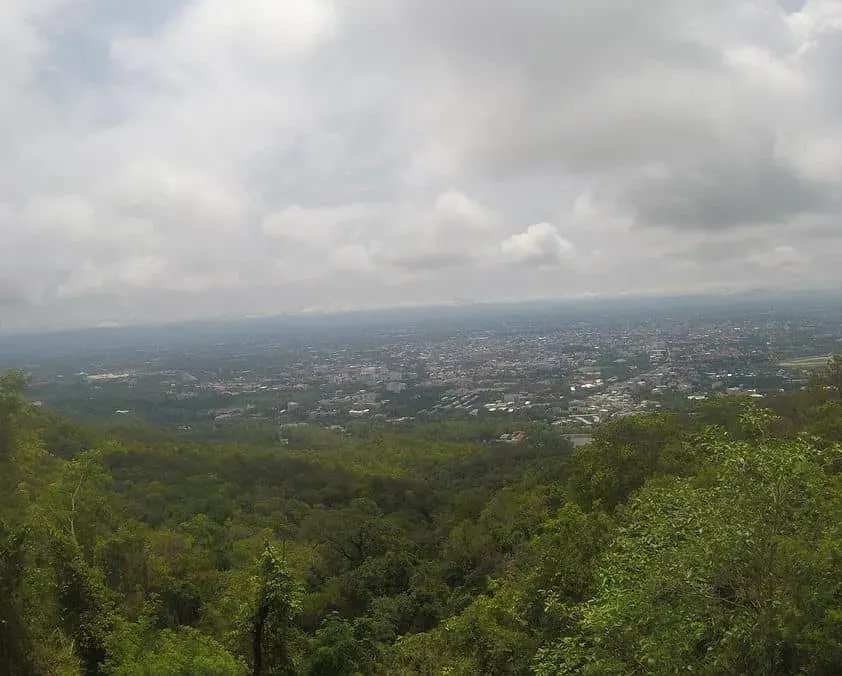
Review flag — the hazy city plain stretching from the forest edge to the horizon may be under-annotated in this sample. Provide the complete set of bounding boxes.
[0,298,842,443]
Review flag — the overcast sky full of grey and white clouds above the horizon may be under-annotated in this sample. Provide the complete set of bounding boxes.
[0,0,842,332]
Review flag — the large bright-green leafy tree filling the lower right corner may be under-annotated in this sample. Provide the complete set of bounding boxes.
[537,410,842,674]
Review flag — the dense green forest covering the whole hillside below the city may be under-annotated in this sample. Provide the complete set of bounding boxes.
[0,371,842,676]
